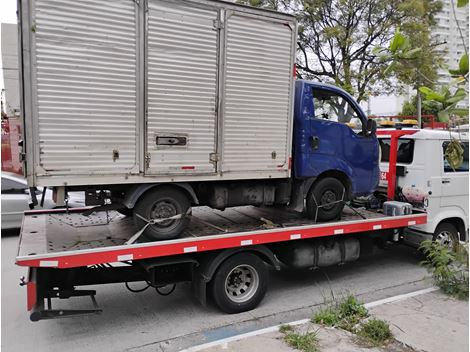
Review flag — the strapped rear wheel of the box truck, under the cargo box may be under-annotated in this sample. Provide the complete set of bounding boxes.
[134,187,191,241]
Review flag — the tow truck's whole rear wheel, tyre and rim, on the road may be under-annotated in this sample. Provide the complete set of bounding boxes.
[210,253,268,314]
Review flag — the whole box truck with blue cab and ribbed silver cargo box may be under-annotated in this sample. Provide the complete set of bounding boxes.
[19,0,379,240]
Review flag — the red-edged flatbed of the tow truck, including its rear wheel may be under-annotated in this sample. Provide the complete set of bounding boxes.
[16,201,426,321]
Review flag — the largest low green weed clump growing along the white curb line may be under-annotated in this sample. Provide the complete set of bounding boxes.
[312,295,369,332]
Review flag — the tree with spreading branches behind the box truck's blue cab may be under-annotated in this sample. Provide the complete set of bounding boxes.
[239,0,442,102]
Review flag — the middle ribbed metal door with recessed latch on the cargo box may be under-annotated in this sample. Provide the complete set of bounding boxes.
[145,1,219,175]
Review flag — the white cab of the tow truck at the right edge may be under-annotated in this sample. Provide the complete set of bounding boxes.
[378,129,469,246]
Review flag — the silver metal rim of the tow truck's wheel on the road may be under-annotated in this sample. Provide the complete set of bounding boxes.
[225,264,259,303]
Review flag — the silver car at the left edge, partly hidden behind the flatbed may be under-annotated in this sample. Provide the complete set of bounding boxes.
[2,171,85,230]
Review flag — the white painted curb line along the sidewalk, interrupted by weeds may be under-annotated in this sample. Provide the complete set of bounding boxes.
[181,287,439,352]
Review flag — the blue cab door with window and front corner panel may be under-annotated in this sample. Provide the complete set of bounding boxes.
[309,87,379,193]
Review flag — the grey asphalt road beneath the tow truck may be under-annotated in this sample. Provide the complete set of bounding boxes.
[1,231,432,352]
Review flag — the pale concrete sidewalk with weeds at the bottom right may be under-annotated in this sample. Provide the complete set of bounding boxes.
[188,291,469,352]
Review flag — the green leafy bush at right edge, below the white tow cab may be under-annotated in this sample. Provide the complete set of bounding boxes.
[420,241,469,300]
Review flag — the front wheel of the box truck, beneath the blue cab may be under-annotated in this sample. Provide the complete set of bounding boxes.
[307,177,346,221]
